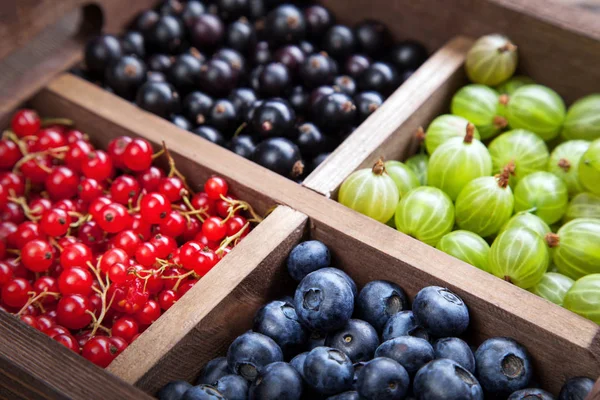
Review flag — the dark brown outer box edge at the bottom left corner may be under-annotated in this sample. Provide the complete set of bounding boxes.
[0,311,151,400]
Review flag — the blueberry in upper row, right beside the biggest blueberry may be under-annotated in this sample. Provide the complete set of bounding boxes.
[356,281,408,332]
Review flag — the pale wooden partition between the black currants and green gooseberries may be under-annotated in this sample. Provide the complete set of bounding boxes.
[303,37,473,197]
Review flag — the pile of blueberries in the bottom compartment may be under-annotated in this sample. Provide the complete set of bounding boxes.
[158,241,594,400]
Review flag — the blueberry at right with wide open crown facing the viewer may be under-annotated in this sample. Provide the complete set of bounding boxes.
[475,337,533,396]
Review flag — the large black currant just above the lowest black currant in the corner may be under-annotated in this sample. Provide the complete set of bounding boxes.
[252,99,296,138]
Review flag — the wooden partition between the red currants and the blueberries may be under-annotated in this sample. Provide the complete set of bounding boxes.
[108,206,307,393]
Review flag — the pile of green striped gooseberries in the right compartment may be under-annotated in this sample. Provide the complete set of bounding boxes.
[339,35,600,324]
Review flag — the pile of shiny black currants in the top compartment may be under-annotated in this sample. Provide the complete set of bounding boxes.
[75,0,427,180]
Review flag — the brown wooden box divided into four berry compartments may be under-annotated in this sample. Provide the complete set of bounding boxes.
[0,0,600,399]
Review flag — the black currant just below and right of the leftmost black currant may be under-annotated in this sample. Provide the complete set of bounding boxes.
[104,56,146,100]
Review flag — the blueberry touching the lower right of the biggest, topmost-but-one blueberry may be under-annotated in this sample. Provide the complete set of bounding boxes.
[325,319,379,362]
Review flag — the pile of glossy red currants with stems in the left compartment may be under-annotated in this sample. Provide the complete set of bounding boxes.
[0,110,261,367]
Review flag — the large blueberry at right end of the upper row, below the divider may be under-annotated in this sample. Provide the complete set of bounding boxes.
[413,286,469,337]
